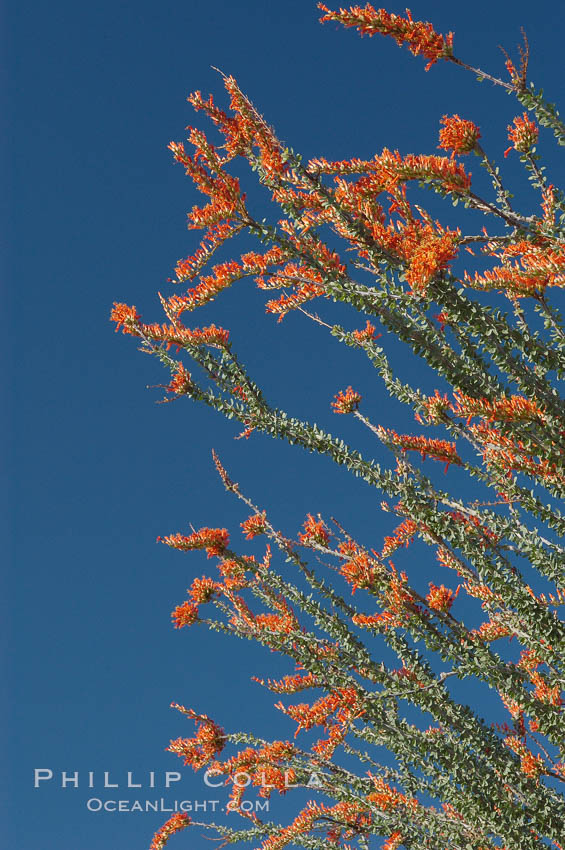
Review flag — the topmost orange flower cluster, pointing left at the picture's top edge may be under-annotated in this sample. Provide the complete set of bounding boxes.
[318,3,453,71]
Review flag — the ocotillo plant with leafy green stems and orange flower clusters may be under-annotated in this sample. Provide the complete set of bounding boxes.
[112,5,565,850]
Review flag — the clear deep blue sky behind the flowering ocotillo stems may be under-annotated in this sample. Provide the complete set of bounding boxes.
[6,0,563,850]
